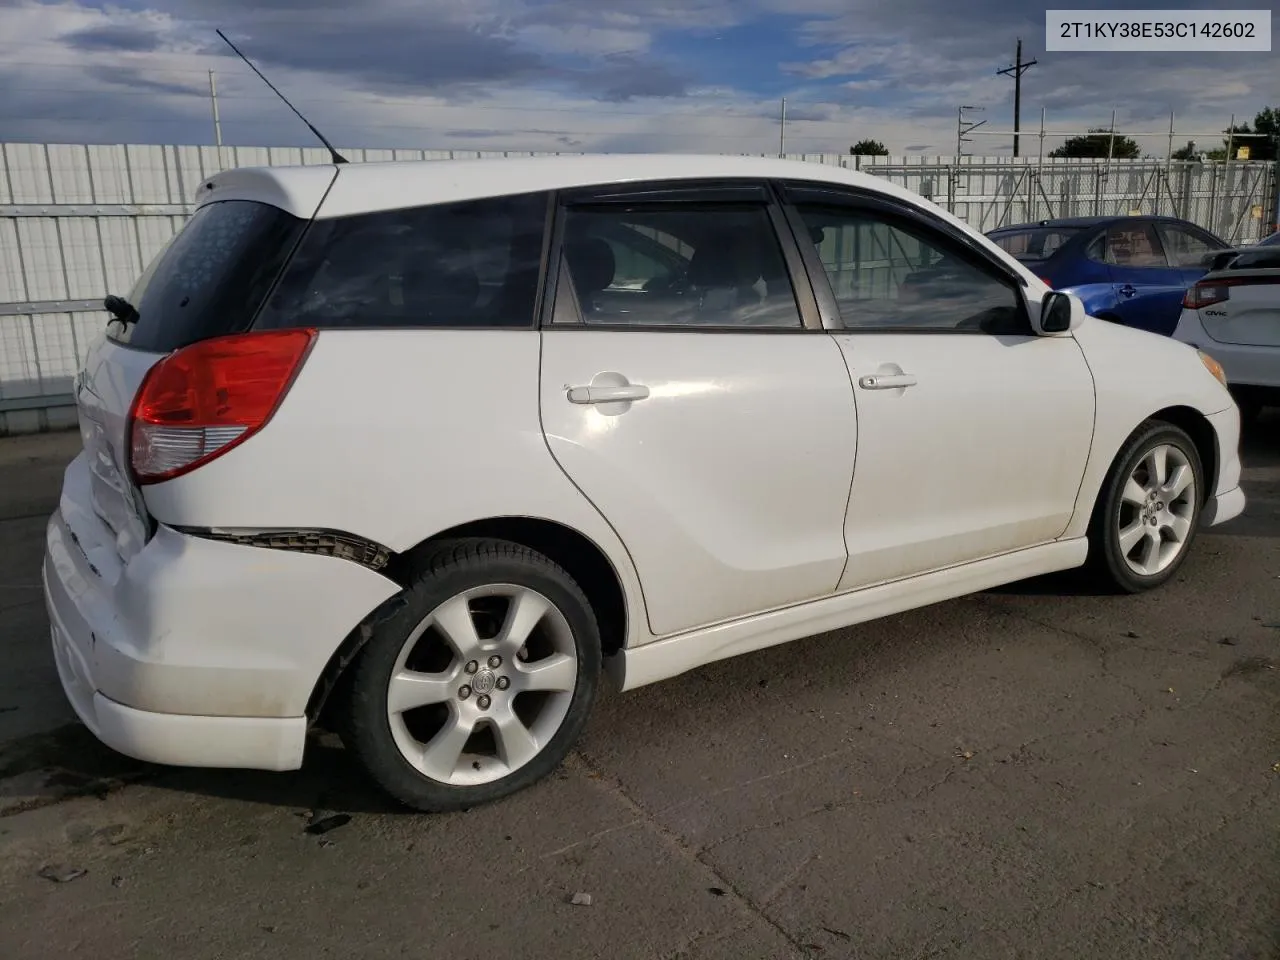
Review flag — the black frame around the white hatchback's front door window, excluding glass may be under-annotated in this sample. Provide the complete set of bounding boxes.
[785,182,1036,338]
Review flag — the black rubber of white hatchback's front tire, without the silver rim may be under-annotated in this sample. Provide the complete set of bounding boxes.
[1088,420,1204,594]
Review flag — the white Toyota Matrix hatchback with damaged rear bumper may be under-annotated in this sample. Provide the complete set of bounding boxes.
[44,156,1244,810]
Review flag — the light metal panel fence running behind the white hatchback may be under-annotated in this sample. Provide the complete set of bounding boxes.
[0,143,1276,435]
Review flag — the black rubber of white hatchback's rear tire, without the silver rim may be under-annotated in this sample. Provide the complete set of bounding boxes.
[342,539,600,813]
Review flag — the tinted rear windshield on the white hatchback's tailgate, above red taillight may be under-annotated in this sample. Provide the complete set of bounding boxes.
[109,200,306,353]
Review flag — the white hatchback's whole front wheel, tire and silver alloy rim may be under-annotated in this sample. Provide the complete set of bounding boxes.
[1089,420,1204,594]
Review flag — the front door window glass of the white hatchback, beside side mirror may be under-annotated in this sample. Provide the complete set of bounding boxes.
[800,206,1029,334]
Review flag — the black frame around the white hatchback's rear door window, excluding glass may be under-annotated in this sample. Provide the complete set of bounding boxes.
[539,178,824,335]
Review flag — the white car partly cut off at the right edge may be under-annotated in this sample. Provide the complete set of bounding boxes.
[1174,233,1280,419]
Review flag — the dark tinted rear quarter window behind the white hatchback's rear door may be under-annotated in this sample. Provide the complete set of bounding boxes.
[256,193,549,329]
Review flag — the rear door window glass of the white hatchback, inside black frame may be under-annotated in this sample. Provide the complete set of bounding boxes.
[564,205,801,328]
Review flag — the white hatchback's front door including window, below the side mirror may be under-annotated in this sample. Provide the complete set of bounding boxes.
[787,184,1094,590]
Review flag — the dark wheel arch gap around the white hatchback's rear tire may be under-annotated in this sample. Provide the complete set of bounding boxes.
[306,516,634,723]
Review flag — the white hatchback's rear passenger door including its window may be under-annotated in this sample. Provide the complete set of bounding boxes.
[540,182,856,635]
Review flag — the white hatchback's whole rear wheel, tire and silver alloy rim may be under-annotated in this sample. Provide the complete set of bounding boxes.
[346,539,600,813]
